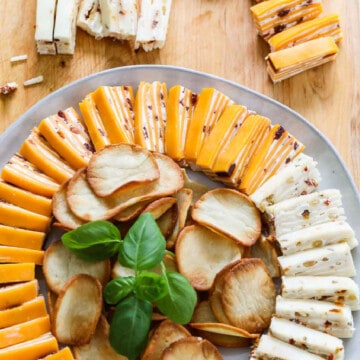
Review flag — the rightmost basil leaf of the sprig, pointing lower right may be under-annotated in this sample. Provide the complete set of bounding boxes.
[156,271,197,324]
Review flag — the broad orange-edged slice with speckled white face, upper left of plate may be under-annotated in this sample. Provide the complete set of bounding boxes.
[38,108,93,169]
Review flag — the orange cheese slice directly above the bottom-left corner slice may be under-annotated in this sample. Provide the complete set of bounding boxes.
[0,315,50,349]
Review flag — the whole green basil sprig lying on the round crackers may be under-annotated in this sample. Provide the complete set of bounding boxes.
[62,213,197,360]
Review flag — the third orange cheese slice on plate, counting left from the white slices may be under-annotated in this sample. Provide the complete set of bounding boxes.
[196,105,249,172]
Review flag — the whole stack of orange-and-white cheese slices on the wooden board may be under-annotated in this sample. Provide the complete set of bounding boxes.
[250,0,343,83]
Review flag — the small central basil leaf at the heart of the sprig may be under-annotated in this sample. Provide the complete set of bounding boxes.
[135,272,168,302]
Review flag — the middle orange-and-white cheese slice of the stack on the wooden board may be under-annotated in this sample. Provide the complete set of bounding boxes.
[268,13,343,52]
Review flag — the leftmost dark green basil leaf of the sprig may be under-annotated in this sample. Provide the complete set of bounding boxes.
[61,220,121,261]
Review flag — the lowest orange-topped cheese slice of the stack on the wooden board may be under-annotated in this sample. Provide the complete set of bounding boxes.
[266,36,339,83]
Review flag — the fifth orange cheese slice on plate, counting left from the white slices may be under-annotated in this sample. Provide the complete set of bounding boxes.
[165,85,198,161]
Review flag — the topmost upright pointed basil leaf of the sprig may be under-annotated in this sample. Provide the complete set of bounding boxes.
[119,213,166,271]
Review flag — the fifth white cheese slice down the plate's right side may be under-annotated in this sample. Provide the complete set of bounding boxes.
[281,276,360,311]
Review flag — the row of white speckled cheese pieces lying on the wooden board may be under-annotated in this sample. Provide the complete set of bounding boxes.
[35,0,171,55]
